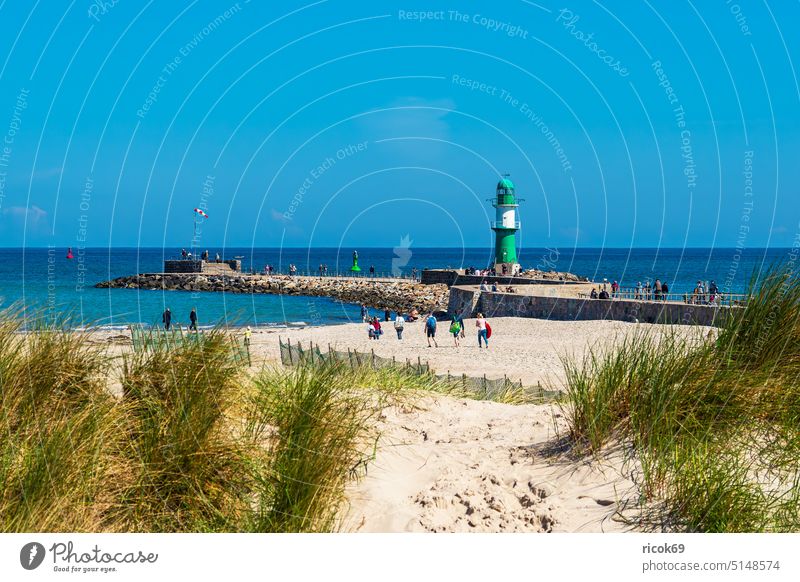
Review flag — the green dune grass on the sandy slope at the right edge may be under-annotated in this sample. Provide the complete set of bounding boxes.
[564,267,800,532]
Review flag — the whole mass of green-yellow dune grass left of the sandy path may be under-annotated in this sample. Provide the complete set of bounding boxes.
[6,313,513,532]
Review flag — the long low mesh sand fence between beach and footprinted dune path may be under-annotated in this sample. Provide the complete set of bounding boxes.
[278,338,563,401]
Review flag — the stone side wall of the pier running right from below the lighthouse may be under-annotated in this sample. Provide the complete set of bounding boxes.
[448,287,736,325]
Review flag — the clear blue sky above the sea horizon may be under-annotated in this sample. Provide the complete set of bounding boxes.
[0,0,800,247]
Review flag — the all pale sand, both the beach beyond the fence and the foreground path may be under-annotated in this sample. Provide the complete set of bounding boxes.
[89,318,708,532]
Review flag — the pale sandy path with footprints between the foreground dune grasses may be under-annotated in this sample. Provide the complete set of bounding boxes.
[342,397,638,532]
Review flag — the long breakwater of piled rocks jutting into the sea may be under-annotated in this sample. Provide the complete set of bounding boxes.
[95,273,449,313]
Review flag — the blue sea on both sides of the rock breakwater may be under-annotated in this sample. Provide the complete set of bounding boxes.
[0,247,790,327]
